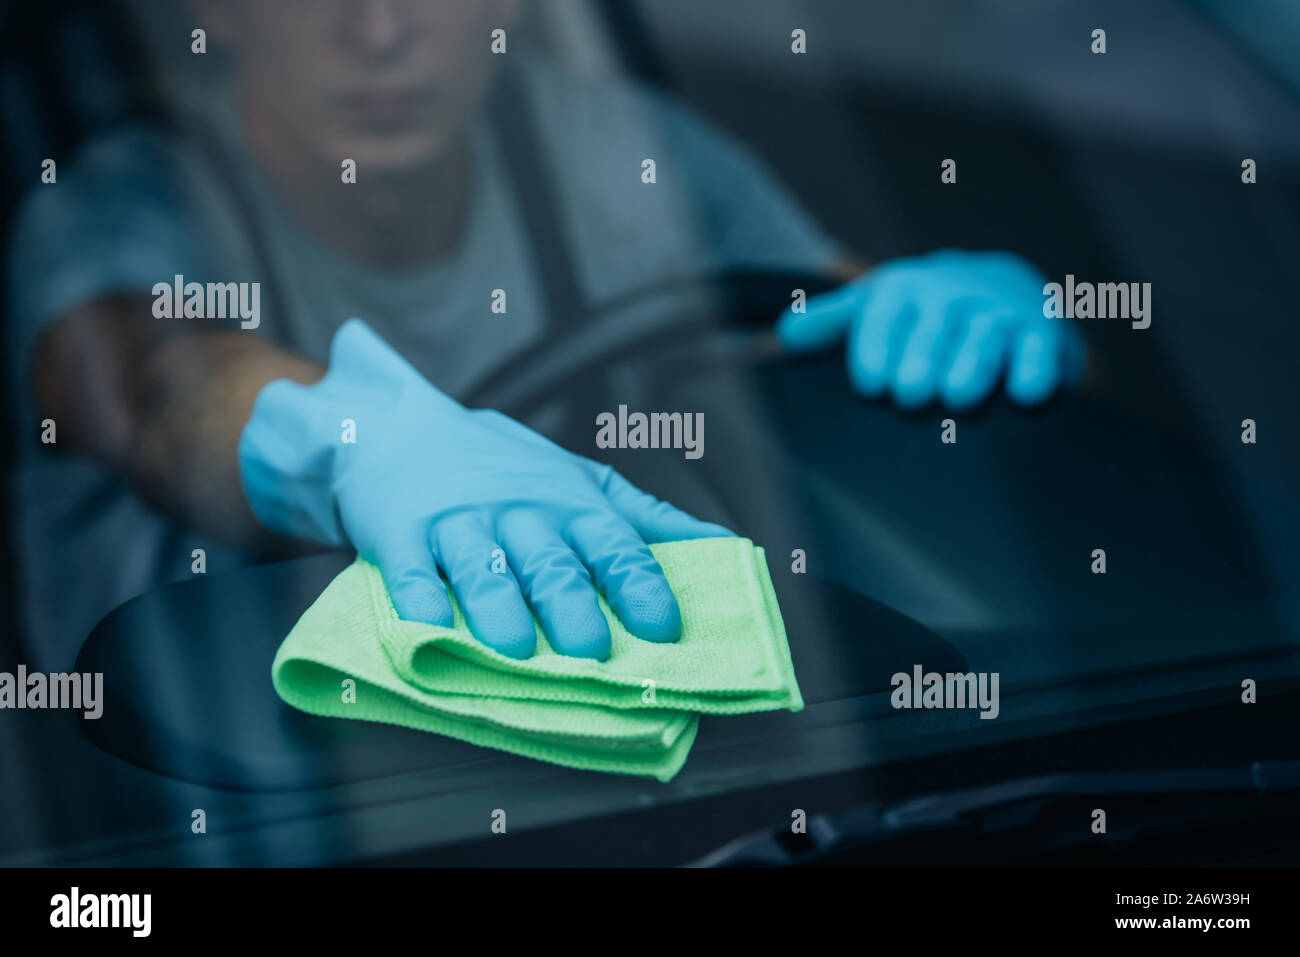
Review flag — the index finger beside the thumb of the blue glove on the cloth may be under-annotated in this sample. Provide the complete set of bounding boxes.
[568,510,681,641]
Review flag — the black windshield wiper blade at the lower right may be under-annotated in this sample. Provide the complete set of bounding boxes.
[689,761,1300,867]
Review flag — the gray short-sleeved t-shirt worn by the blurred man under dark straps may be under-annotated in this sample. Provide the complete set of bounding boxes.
[8,64,839,668]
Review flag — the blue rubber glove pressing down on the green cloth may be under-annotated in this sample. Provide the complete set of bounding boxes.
[239,319,731,659]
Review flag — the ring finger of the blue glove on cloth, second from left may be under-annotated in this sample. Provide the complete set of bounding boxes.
[433,512,537,658]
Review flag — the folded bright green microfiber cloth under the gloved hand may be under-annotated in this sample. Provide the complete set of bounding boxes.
[272,538,803,780]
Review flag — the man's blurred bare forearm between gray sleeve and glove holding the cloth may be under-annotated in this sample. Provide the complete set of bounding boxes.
[34,299,324,544]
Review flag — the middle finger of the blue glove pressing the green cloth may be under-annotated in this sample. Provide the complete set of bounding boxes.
[498,510,610,661]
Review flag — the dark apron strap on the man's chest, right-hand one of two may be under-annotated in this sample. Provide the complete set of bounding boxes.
[488,65,588,329]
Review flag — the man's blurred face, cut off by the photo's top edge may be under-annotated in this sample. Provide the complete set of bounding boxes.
[204,0,519,176]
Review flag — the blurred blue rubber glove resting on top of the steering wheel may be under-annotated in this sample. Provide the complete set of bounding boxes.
[776,250,1084,410]
